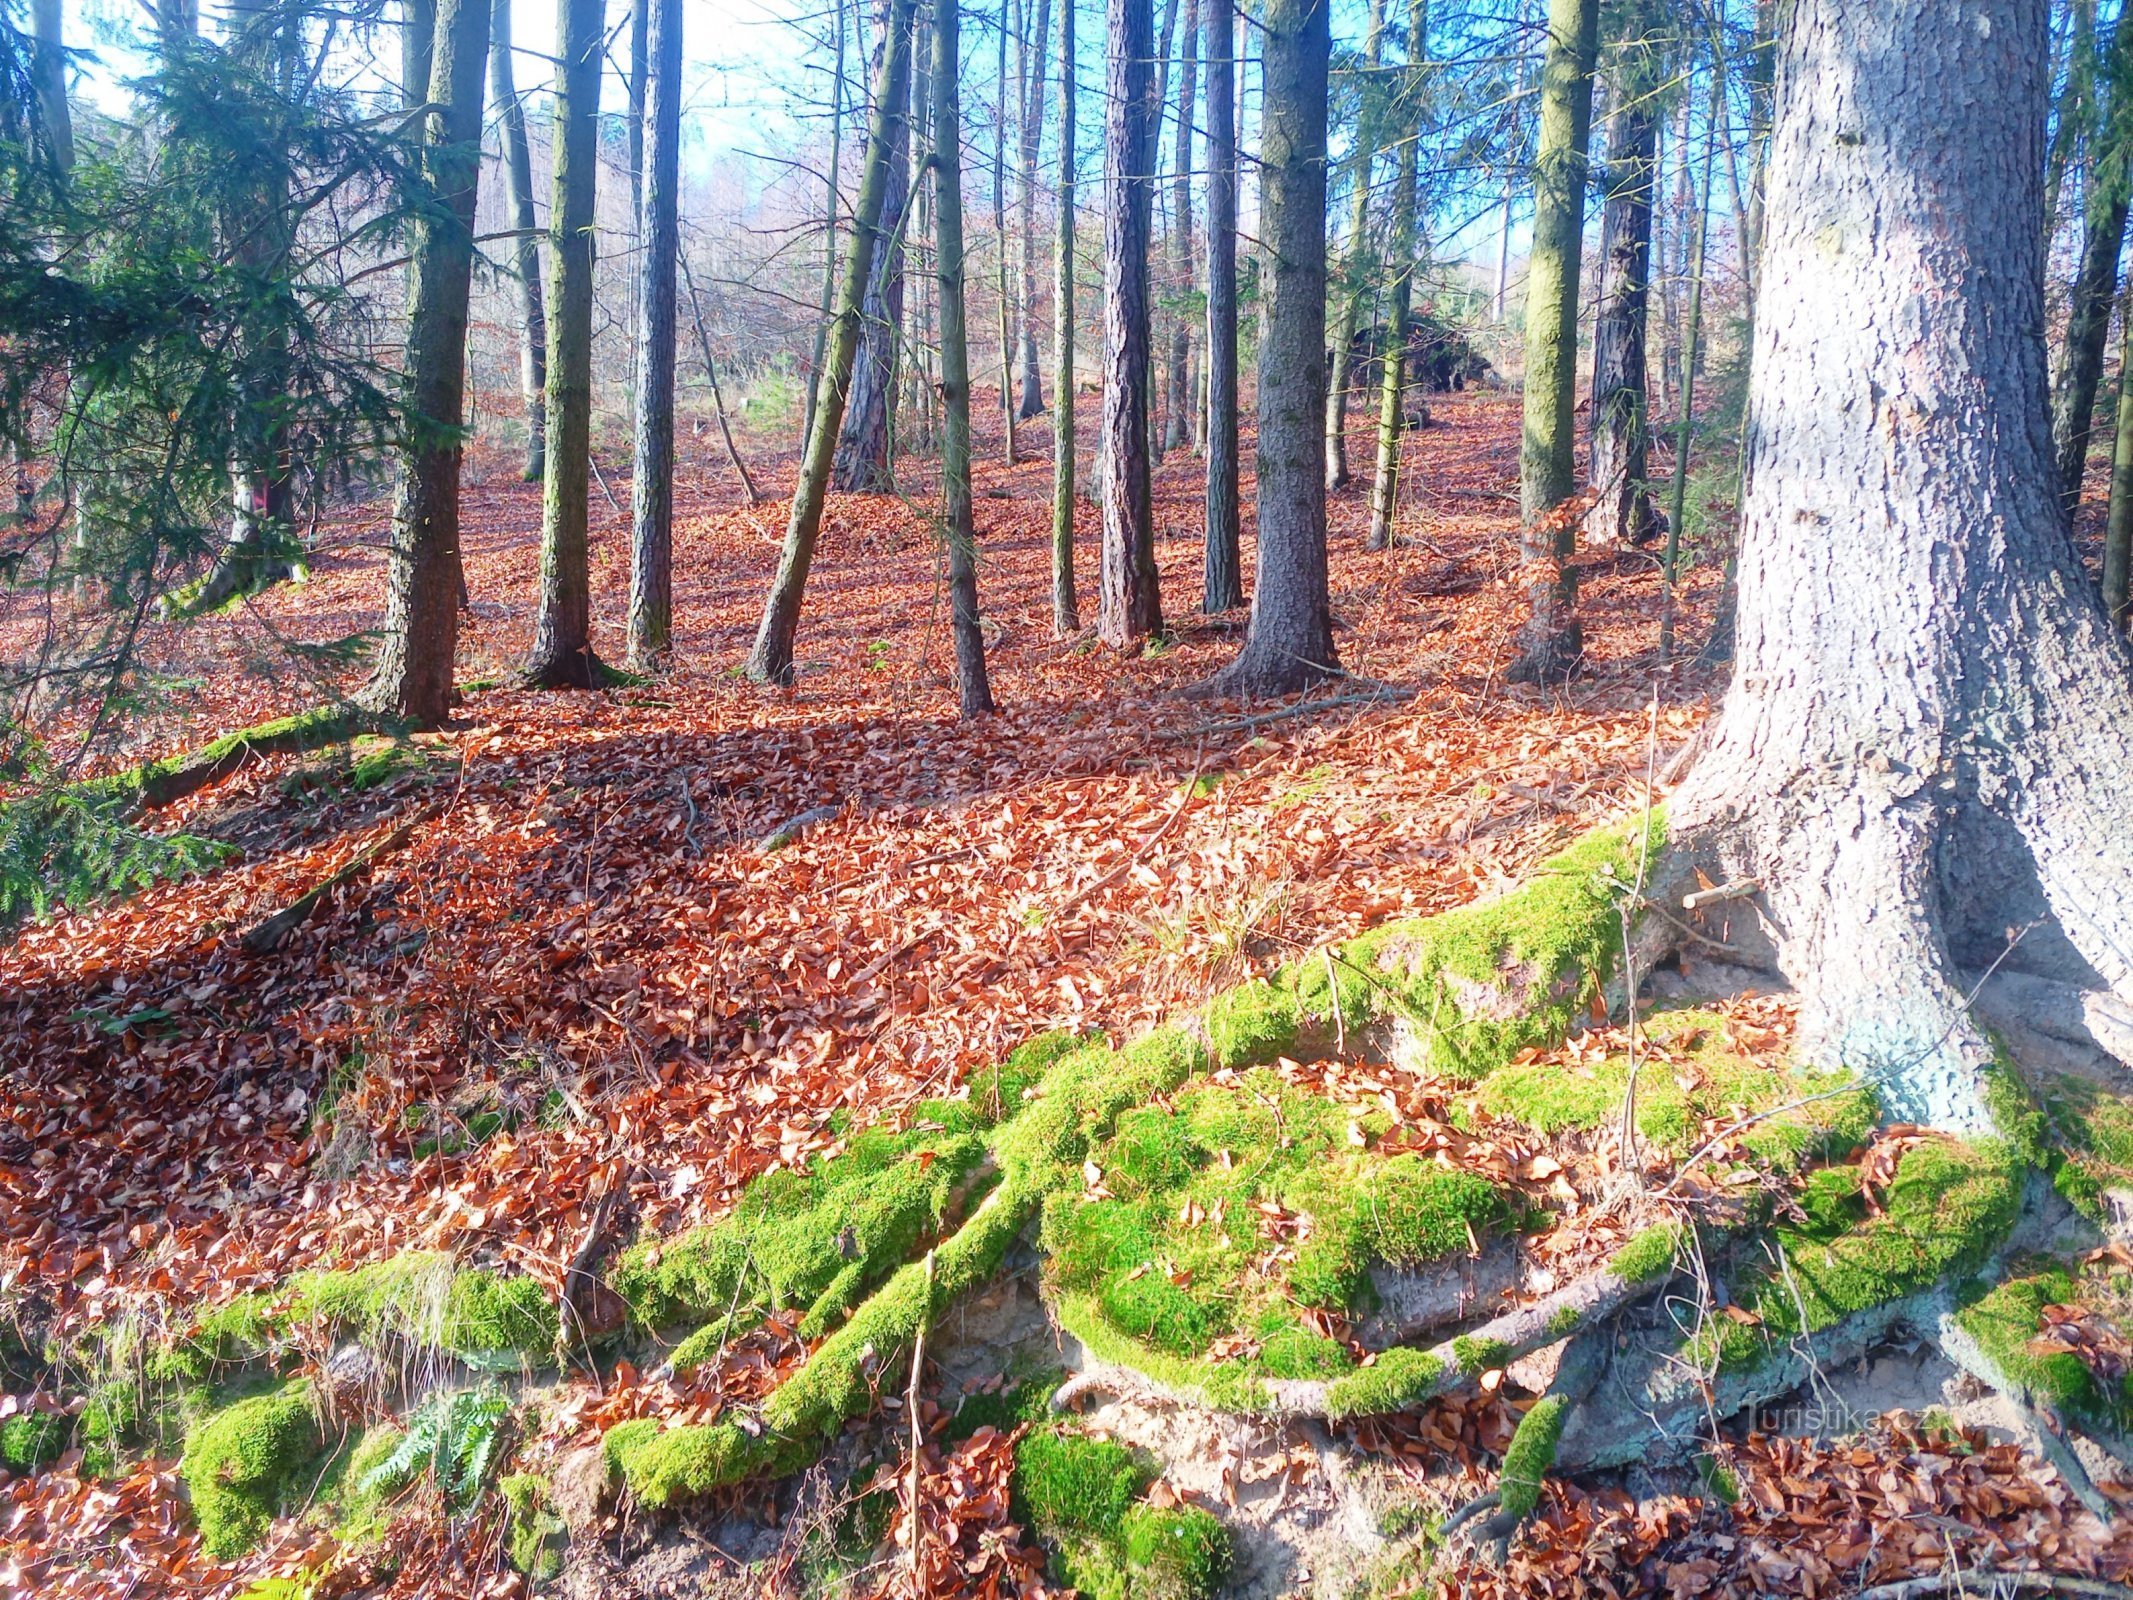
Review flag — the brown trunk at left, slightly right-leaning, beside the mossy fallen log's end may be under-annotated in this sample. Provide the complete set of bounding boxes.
[363,0,491,727]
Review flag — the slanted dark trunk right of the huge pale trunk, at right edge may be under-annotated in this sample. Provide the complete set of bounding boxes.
[2052,6,2133,516]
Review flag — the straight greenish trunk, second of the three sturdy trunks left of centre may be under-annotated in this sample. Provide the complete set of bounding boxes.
[525,0,606,689]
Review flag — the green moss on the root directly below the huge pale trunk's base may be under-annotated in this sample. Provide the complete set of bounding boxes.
[1717,1139,2024,1367]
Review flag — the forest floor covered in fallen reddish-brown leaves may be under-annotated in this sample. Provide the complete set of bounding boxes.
[0,395,2133,1600]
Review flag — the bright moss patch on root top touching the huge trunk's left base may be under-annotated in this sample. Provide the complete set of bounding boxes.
[1288,817,1666,1077]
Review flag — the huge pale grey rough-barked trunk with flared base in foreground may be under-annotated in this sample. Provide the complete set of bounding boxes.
[1668,0,2133,1131]
